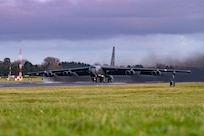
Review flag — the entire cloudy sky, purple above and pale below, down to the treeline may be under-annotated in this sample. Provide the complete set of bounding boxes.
[0,0,204,66]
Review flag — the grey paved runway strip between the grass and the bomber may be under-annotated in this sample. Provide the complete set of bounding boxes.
[0,82,131,88]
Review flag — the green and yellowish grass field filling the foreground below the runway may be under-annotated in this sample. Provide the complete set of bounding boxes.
[0,83,204,136]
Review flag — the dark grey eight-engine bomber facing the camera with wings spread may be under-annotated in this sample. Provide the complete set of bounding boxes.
[28,47,191,86]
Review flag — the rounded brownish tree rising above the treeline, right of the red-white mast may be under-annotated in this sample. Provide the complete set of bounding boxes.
[42,57,60,70]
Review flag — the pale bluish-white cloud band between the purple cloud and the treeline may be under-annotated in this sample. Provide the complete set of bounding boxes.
[0,34,204,66]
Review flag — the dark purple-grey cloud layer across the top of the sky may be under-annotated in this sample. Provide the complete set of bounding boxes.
[0,0,204,40]
